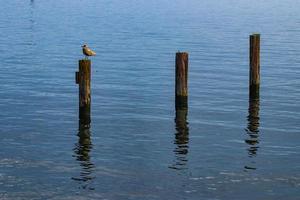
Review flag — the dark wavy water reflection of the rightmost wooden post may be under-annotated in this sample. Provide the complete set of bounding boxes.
[245,98,259,170]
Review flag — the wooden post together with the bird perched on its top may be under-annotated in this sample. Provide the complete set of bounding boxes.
[76,44,96,124]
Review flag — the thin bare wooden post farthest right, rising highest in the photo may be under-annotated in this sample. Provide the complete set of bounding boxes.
[249,34,260,99]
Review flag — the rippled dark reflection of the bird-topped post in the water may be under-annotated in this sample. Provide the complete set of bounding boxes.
[72,115,95,190]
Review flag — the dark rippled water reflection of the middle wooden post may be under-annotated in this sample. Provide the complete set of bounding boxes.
[170,107,189,170]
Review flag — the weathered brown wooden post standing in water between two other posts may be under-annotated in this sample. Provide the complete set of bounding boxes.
[175,52,188,108]
